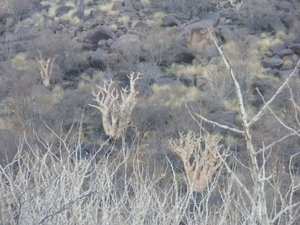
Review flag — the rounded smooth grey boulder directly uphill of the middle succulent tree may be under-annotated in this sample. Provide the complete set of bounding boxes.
[110,34,142,58]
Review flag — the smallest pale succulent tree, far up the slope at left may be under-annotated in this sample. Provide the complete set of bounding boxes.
[36,51,55,87]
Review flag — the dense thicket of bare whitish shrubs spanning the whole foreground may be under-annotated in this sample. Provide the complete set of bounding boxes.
[0,111,299,225]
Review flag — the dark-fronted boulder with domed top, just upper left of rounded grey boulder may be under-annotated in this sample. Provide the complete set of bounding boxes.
[84,25,116,45]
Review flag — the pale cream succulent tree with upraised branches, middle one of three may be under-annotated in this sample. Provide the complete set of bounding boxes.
[90,73,141,139]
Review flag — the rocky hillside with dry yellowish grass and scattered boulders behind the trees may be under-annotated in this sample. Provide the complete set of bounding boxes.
[0,0,300,171]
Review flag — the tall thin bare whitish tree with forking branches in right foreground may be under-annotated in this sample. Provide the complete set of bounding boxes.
[190,29,300,225]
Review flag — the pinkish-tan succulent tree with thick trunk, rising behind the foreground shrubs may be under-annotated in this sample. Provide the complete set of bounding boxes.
[169,131,227,192]
